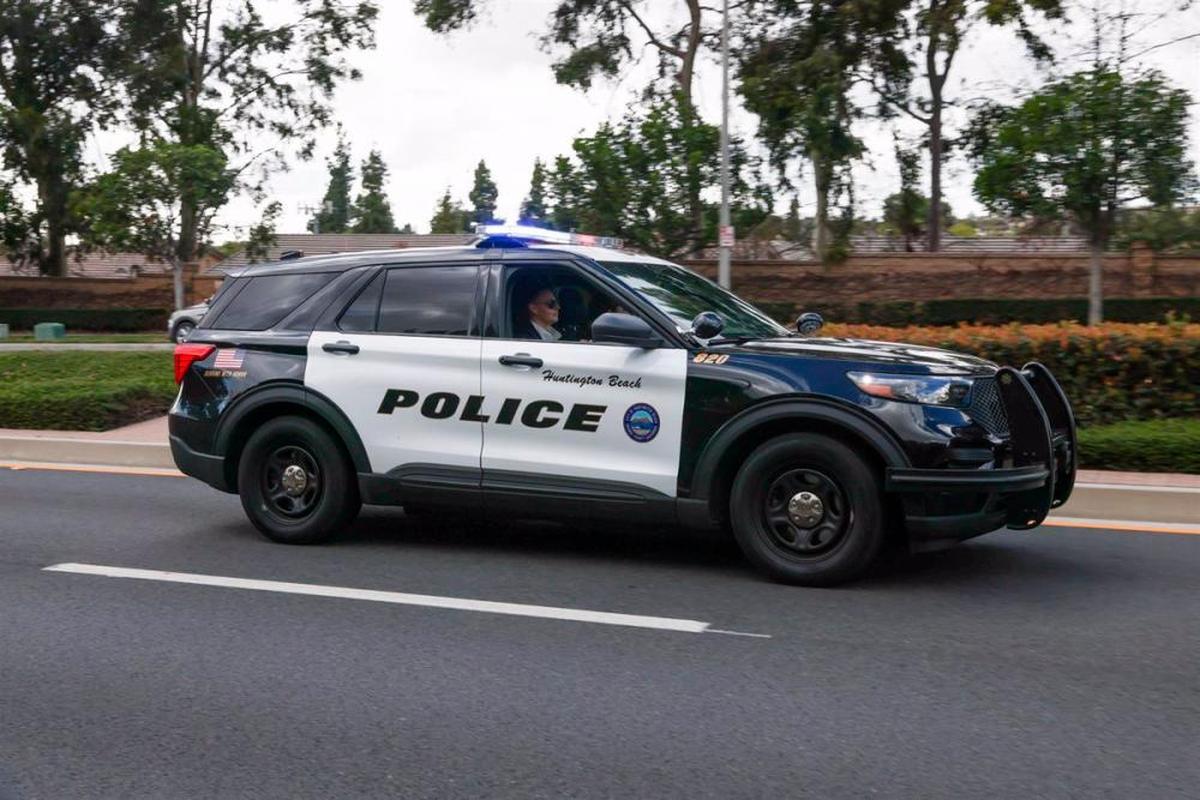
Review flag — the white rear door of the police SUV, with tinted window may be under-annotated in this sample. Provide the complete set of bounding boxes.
[305,264,482,482]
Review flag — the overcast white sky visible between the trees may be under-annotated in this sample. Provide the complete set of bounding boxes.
[199,0,1200,241]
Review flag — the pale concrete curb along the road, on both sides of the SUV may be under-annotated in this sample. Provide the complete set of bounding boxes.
[0,435,1200,525]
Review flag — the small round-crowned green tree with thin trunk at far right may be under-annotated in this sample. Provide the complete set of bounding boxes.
[970,65,1195,325]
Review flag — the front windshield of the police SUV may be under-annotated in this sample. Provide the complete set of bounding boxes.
[602,261,790,338]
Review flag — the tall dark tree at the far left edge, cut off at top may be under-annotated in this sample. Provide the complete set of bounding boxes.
[0,0,114,275]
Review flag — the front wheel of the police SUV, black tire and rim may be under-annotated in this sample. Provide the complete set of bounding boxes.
[730,433,886,587]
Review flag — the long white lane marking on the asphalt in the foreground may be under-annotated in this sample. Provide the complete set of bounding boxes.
[43,564,768,633]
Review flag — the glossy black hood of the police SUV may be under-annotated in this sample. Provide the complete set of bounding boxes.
[742,338,996,374]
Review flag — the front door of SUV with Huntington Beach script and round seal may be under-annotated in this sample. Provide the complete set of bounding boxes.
[481,265,686,498]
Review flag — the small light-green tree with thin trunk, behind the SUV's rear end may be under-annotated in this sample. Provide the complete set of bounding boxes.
[76,140,236,308]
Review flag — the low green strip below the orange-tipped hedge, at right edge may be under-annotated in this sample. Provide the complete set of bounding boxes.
[1079,419,1200,474]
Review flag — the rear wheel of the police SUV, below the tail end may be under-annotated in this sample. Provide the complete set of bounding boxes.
[238,416,362,545]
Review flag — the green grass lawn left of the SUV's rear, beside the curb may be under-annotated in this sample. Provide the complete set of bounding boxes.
[0,350,175,431]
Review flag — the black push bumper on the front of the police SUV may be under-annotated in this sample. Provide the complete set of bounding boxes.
[884,362,1078,551]
